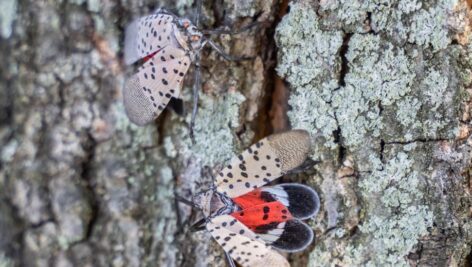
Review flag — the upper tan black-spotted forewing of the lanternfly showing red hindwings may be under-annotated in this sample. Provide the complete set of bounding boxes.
[216,130,310,198]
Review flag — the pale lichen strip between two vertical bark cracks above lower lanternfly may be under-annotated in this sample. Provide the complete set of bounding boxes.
[276,4,343,150]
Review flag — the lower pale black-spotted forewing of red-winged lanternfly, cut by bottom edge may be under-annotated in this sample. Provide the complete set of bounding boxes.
[206,215,290,267]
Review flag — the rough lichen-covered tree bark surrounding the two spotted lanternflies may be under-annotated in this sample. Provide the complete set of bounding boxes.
[0,0,472,266]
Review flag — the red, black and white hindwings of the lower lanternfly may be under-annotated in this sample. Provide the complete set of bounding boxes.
[231,184,319,252]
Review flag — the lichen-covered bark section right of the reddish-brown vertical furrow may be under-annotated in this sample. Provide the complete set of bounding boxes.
[276,0,471,266]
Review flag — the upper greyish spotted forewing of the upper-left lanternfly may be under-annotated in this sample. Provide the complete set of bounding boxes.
[124,13,176,64]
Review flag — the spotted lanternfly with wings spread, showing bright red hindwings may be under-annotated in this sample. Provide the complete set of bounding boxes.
[188,130,320,267]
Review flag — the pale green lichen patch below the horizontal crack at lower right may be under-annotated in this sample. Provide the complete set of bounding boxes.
[310,152,433,266]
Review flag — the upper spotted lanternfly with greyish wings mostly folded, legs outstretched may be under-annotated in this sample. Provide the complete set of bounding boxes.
[123,6,255,138]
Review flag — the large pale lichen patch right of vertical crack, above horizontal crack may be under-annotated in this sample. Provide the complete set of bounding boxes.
[332,34,460,147]
